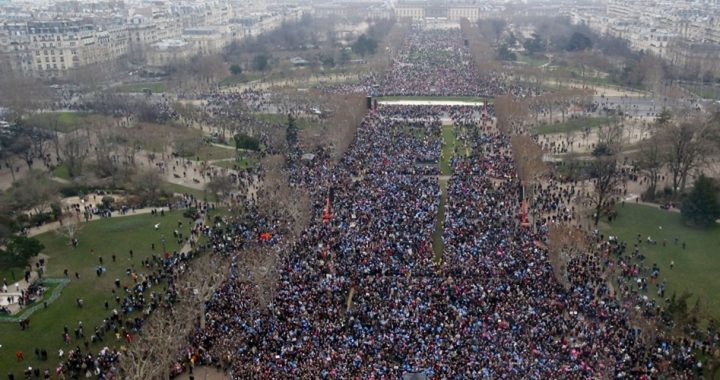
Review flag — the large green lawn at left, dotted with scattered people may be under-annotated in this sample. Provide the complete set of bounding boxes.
[0,211,190,379]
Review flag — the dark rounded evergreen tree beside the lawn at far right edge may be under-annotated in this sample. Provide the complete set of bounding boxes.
[680,174,720,227]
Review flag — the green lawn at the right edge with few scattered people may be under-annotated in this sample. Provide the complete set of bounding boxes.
[606,203,720,318]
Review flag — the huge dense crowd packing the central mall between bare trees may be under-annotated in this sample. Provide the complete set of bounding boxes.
[153,24,699,379]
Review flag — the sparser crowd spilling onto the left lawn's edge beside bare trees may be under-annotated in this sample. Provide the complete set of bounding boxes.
[17,196,210,379]
